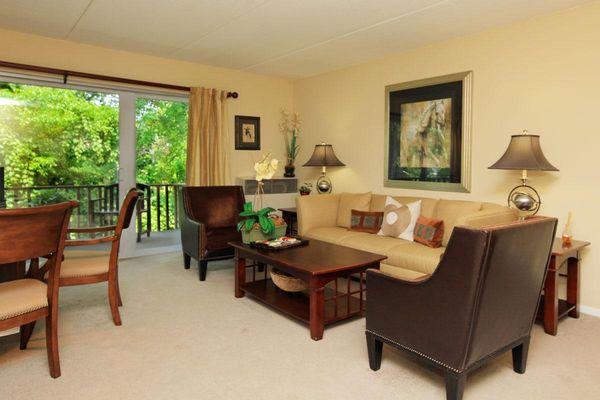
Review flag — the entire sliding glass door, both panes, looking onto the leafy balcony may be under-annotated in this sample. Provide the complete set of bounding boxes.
[0,78,187,257]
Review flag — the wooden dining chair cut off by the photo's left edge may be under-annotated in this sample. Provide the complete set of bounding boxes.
[0,201,77,378]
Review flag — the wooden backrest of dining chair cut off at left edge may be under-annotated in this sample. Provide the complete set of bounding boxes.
[0,201,78,264]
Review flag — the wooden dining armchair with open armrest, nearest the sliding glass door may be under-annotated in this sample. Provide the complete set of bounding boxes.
[59,188,139,326]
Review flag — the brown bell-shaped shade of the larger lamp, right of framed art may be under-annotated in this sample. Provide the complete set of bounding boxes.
[489,133,558,171]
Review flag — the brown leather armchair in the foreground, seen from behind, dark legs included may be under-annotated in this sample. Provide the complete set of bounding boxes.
[366,217,556,400]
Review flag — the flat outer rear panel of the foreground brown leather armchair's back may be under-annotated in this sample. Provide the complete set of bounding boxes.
[466,217,557,365]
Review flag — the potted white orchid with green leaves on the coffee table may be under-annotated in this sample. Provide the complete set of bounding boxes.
[237,153,287,244]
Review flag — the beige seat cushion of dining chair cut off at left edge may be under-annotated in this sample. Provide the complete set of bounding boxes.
[0,279,48,321]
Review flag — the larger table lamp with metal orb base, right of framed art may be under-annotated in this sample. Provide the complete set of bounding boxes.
[489,130,558,215]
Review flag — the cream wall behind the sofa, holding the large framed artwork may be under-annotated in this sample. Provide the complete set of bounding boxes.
[294,2,600,315]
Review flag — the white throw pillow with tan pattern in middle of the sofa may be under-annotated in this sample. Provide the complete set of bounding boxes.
[377,196,421,242]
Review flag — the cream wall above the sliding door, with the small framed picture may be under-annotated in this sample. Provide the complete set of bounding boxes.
[0,30,292,183]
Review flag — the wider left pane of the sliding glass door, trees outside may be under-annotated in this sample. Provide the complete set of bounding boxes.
[0,82,119,227]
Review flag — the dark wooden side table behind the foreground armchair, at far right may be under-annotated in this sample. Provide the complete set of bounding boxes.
[537,238,590,336]
